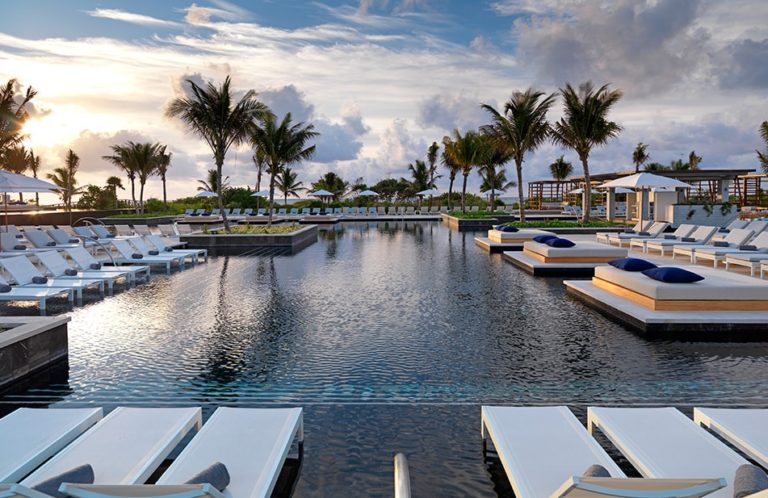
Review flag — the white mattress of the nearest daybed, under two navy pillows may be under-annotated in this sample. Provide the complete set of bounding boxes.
[593,266,768,301]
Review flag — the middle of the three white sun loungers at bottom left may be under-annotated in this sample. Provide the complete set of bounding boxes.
[21,407,201,487]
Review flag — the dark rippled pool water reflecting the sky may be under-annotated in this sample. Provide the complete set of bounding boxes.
[0,222,768,497]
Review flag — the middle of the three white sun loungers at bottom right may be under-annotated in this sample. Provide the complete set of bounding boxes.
[587,407,748,498]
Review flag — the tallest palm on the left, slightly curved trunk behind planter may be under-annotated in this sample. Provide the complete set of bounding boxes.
[165,76,271,232]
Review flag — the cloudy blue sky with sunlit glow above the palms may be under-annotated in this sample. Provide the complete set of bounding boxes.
[0,0,768,198]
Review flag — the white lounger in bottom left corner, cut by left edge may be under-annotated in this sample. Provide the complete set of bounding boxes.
[0,408,102,483]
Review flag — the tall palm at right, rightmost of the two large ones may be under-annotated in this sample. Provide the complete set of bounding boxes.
[552,81,622,222]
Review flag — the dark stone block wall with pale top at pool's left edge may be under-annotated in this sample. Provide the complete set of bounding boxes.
[0,316,70,389]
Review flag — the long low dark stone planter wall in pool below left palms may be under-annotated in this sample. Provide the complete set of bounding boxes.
[180,225,317,255]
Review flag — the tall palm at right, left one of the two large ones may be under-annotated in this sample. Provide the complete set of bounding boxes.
[482,88,556,221]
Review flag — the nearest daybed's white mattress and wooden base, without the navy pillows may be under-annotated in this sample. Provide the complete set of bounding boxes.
[592,266,768,313]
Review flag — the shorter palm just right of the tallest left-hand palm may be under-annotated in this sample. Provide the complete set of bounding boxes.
[251,112,319,226]
